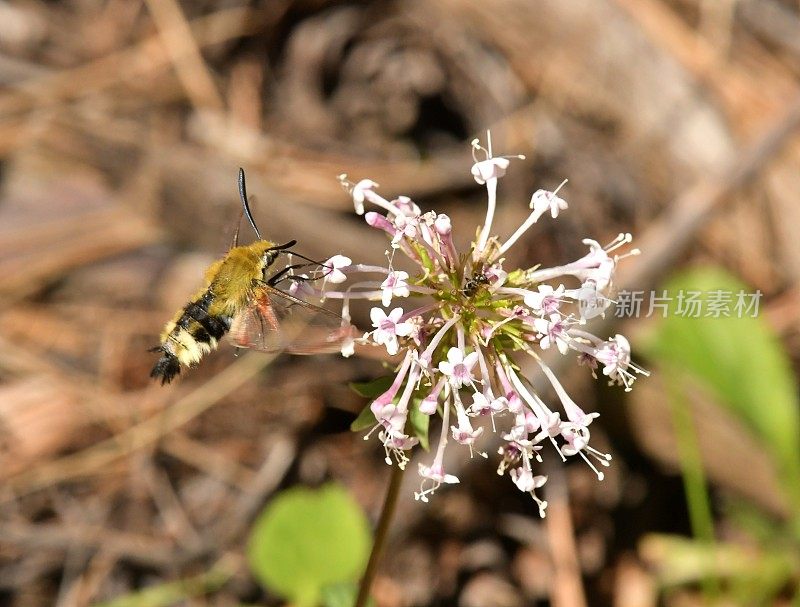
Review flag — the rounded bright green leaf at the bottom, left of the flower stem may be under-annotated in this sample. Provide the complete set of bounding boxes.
[247,484,372,607]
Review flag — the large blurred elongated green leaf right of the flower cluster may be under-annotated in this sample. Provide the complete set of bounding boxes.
[645,267,800,505]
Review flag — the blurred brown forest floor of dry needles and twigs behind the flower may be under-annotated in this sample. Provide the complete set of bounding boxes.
[0,0,800,607]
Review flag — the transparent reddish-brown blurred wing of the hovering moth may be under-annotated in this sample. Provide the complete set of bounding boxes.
[229,285,346,354]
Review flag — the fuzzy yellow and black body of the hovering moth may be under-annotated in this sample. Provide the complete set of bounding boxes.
[150,240,280,384]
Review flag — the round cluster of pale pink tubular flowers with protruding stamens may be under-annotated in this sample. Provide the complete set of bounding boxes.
[322,134,646,516]
